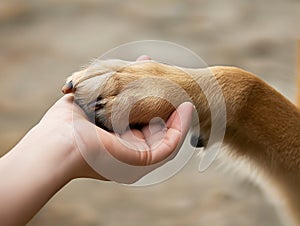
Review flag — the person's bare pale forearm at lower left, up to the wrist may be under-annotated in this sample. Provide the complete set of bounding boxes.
[0,126,75,225]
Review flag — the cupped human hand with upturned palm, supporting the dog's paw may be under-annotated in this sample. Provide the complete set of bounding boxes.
[39,95,193,183]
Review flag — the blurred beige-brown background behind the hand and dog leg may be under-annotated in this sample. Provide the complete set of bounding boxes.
[0,0,300,226]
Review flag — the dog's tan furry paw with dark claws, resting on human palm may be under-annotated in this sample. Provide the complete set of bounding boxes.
[63,60,183,133]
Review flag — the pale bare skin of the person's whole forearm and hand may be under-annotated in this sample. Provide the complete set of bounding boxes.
[0,56,193,225]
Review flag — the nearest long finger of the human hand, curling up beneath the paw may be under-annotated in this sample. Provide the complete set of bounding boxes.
[98,103,193,166]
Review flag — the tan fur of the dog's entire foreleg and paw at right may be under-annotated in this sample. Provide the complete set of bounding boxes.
[65,61,300,225]
